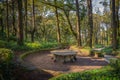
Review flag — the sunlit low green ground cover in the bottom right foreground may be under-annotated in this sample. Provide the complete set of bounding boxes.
[50,67,120,80]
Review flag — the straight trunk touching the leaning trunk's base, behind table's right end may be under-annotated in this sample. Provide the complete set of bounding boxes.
[76,0,82,46]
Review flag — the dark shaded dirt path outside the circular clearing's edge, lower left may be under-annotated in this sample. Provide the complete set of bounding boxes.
[13,51,53,80]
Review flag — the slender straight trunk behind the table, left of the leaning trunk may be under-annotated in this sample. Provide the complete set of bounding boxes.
[55,0,61,43]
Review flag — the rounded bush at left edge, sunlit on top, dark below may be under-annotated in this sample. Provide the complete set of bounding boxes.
[0,48,13,80]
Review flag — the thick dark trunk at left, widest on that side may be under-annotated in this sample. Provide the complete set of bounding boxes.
[17,0,23,45]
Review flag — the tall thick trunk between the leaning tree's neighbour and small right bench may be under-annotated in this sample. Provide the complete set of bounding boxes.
[87,0,93,48]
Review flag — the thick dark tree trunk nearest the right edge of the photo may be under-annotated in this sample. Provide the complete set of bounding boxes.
[111,0,117,50]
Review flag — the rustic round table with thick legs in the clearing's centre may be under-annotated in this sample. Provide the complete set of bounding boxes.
[51,50,77,63]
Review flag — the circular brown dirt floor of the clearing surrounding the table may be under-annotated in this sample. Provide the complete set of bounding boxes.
[24,51,107,75]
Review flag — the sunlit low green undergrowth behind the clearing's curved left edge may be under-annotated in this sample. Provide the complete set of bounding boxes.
[6,41,58,51]
